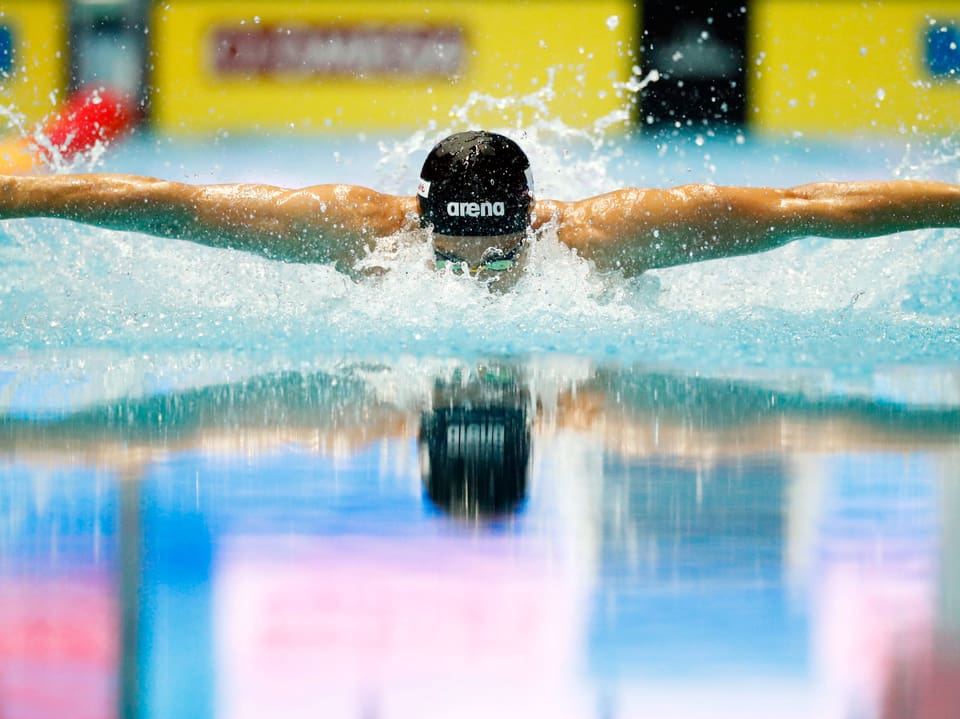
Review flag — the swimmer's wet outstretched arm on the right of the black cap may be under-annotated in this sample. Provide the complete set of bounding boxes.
[537,180,960,274]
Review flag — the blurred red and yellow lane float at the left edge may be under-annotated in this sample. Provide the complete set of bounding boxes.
[0,88,133,175]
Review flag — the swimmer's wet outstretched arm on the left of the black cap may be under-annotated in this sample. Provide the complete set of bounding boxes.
[0,174,416,264]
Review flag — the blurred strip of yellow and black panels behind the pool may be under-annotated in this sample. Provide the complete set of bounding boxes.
[0,0,960,135]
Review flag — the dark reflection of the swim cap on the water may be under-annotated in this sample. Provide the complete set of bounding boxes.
[420,406,530,517]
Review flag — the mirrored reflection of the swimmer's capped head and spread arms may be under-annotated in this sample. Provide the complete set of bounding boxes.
[7,360,960,517]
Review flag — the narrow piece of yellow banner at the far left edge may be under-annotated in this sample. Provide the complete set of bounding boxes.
[0,0,67,128]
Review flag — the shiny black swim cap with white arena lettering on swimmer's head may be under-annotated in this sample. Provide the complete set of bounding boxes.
[417,132,533,237]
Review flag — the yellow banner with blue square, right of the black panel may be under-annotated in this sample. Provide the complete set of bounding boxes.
[748,0,960,133]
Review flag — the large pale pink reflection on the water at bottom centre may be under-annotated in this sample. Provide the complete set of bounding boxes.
[214,537,583,719]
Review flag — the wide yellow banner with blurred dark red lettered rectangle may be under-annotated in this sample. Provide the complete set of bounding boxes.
[151,0,638,132]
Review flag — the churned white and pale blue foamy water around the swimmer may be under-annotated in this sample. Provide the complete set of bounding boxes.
[0,78,960,406]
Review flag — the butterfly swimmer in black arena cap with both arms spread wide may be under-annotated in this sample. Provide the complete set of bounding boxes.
[0,131,960,277]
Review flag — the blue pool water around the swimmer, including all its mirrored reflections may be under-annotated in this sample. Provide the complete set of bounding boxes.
[0,111,960,719]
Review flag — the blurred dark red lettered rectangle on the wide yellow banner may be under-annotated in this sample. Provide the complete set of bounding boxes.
[210,25,466,77]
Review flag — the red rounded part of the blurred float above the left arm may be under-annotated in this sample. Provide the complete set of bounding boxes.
[41,88,134,160]
